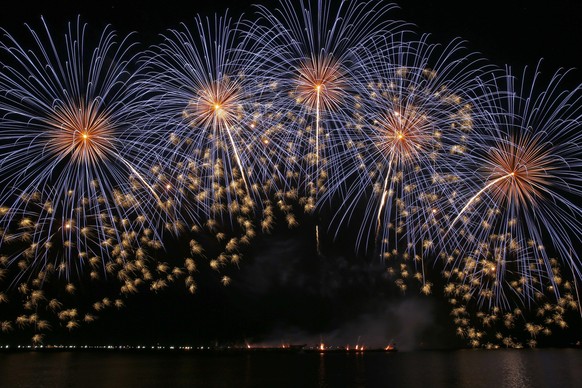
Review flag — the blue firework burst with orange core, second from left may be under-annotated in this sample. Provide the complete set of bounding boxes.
[140,12,283,293]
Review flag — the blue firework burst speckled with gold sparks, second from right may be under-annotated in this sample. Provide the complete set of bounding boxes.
[326,33,486,270]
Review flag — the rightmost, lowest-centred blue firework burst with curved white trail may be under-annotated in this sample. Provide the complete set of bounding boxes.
[449,65,582,306]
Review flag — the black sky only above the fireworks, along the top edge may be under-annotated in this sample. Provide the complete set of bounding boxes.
[0,0,582,68]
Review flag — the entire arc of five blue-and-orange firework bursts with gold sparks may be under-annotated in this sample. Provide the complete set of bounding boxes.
[0,0,582,348]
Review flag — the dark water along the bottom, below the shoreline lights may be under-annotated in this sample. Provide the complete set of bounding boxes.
[0,349,582,388]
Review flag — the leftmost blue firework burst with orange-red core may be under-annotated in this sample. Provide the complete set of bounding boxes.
[0,19,171,276]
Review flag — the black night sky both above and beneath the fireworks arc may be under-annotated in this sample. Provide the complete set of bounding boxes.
[0,0,582,349]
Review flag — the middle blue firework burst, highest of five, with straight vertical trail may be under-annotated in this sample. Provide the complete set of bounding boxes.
[249,0,401,200]
